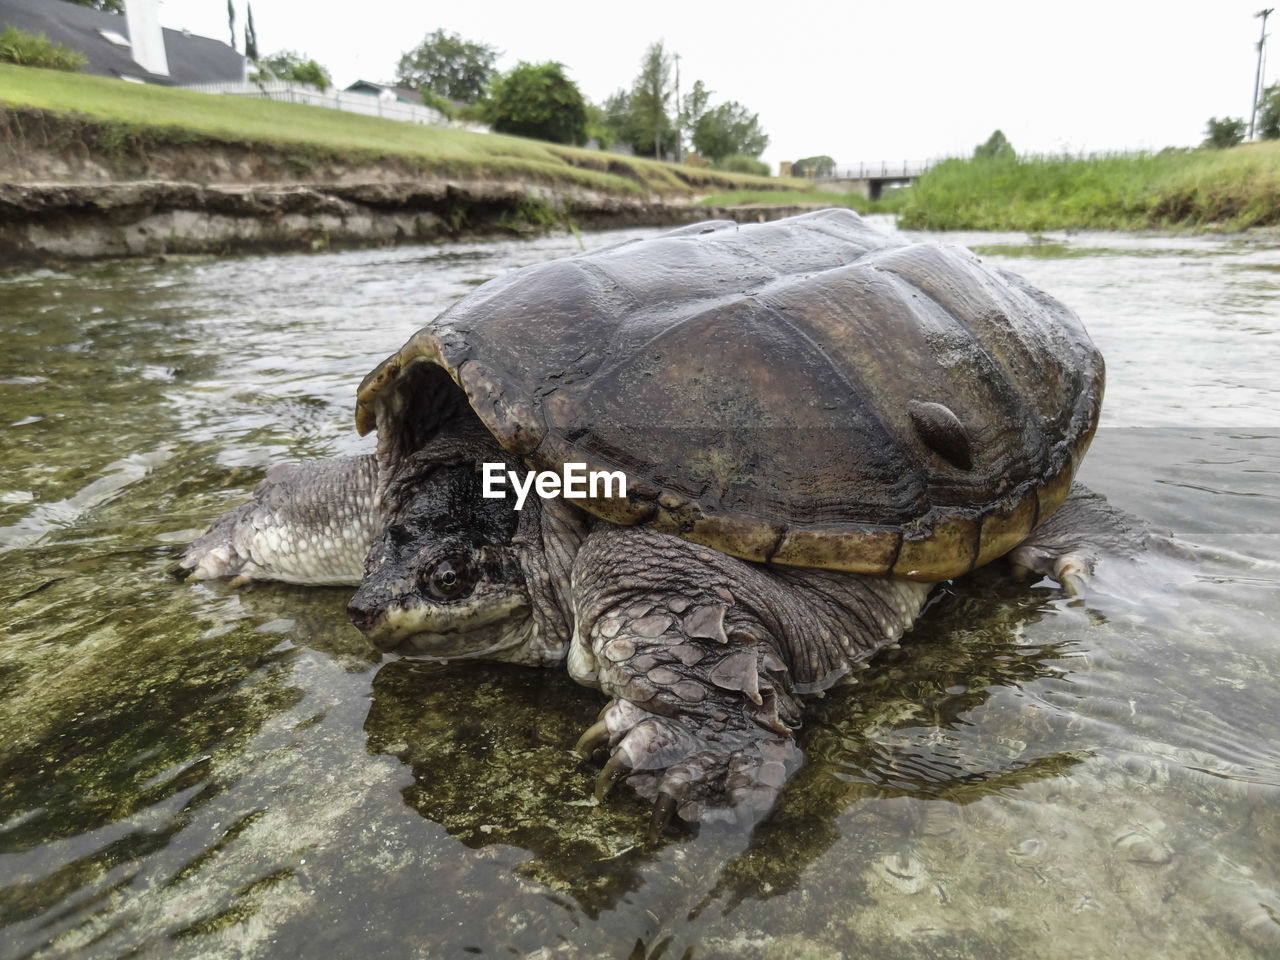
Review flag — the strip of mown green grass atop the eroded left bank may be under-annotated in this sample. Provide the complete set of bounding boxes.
[0,64,787,196]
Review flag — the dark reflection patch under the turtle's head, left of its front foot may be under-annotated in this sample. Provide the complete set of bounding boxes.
[365,660,650,915]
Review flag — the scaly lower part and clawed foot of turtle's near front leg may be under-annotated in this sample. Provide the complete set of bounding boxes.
[576,596,801,838]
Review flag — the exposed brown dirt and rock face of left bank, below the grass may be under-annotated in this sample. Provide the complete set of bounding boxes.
[0,111,800,265]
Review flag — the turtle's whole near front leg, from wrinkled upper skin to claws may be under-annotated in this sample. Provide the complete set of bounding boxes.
[570,526,928,837]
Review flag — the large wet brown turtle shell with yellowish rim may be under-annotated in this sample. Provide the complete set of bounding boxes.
[357,210,1103,580]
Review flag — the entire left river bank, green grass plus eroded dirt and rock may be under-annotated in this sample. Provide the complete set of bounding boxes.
[0,65,808,264]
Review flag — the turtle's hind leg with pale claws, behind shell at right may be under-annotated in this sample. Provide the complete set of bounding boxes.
[1007,484,1153,596]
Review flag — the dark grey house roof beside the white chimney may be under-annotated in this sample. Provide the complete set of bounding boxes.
[0,0,244,86]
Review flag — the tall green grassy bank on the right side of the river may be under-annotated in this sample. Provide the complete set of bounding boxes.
[897,148,1280,230]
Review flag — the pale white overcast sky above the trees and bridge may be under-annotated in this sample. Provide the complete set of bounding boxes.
[160,0,1280,172]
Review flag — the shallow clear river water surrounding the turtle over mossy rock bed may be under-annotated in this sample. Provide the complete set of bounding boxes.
[0,221,1280,957]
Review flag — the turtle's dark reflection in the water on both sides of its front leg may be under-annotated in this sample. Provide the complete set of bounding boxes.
[365,575,1083,915]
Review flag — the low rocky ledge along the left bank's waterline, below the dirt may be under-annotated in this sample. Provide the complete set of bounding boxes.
[0,165,813,266]
